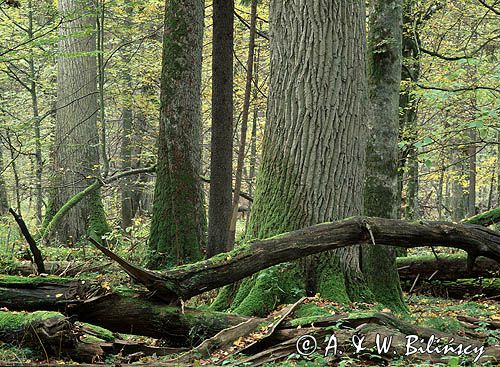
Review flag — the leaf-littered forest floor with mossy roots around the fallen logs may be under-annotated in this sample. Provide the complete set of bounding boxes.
[0,227,500,366]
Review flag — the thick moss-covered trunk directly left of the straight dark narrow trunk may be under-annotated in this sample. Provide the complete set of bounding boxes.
[148,0,205,268]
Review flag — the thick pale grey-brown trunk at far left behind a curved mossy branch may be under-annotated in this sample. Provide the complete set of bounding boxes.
[45,0,108,243]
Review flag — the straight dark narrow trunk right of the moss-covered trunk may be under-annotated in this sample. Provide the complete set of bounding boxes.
[207,0,234,257]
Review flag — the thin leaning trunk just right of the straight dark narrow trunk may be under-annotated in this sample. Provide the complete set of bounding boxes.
[228,0,257,250]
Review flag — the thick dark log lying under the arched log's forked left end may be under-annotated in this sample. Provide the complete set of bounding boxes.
[0,276,249,346]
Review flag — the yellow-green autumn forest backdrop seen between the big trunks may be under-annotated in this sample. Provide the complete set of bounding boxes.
[0,0,500,294]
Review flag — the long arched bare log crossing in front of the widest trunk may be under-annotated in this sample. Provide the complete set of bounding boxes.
[91,217,500,304]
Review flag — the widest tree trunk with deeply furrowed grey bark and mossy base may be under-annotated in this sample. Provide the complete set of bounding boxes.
[227,0,371,314]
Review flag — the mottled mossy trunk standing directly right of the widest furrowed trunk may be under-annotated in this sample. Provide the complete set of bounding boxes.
[362,0,405,310]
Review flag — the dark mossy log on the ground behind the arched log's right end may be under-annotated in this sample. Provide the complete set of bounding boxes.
[396,255,500,280]
